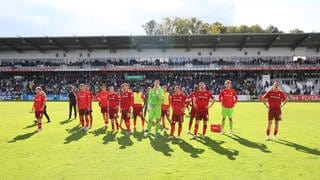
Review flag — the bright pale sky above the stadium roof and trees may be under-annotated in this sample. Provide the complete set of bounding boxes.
[0,0,320,36]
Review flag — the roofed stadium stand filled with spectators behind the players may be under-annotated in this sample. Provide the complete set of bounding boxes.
[0,33,320,101]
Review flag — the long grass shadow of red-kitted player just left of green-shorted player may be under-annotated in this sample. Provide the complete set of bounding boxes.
[196,137,239,160]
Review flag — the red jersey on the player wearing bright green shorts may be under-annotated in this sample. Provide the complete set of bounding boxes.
[219,89,238,108]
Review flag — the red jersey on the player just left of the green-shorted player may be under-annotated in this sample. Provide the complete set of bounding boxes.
[195,90,214,112]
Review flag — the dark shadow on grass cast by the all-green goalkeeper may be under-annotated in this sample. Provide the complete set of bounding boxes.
[149,135,173,156]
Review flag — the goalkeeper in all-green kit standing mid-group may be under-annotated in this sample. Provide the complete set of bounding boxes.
[145,80,163,137]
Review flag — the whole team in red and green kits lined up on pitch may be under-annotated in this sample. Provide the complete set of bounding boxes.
[32,80,287,140]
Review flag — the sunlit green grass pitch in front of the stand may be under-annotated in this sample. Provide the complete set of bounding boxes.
[0,102,320,179]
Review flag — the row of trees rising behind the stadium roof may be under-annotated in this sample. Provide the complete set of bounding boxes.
[142,17,303,35]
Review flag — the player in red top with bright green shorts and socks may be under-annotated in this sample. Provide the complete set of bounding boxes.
[219,80,238,134]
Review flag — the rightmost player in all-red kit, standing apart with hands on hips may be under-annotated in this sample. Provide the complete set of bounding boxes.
[262,82,288,141]
